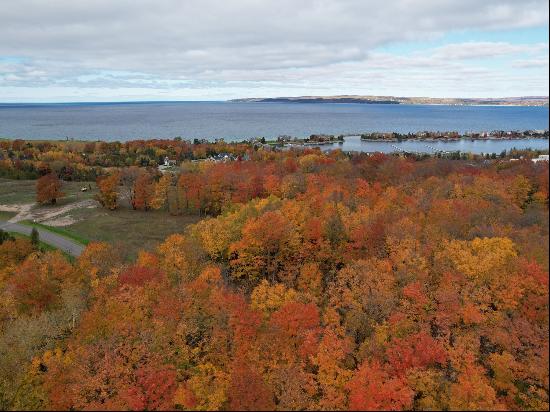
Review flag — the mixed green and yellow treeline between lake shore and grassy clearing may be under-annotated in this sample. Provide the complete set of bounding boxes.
[0,139,254,181]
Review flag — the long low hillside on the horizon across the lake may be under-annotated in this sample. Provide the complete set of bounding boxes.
[230,95,548,106]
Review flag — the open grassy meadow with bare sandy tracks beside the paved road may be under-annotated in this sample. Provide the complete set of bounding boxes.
[0,178,203,259]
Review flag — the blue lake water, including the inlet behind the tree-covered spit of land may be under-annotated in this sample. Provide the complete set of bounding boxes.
[0,102,548,152]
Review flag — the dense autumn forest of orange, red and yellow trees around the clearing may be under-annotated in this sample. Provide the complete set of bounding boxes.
[0,141,549,410]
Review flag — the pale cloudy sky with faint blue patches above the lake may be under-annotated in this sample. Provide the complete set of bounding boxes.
[0,0,549,102]
